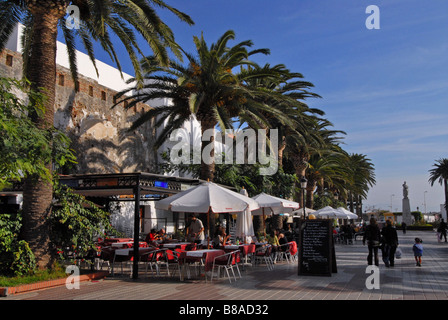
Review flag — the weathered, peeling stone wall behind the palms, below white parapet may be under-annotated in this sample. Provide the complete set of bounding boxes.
[0,49,157,174]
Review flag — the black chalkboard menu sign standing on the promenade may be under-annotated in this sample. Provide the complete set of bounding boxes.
[299,219,337,276]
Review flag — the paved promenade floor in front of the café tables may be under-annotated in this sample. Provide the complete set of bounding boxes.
[4,231,448,303]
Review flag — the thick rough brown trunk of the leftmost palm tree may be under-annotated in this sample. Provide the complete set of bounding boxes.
[21,5,65,268]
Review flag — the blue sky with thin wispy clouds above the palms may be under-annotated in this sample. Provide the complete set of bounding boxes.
[66,0,448,212]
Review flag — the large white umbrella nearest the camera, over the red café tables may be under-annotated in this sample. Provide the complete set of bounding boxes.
[155,182,260,248]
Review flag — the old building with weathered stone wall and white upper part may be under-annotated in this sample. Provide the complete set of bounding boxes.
[0,24,231,236]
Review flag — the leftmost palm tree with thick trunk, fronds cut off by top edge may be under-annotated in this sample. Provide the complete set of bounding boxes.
[0,0,193,267]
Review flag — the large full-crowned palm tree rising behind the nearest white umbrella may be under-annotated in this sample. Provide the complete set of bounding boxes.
[117,30,296,181]
